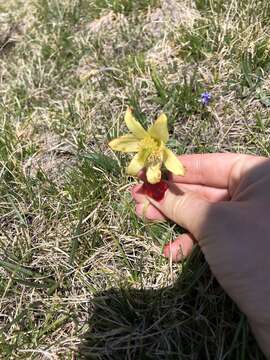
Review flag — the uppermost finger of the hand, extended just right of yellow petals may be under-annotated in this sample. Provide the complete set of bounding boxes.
[170,153,259,188]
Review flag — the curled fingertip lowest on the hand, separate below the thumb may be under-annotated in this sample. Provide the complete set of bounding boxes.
[163,233,194,262]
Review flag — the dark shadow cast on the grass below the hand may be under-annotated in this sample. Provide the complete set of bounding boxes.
[79,249,264,360]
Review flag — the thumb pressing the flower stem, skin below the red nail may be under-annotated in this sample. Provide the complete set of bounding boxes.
[148,185,213,240]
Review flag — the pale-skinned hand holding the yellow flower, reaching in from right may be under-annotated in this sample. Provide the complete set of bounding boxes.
[132,154,270,359]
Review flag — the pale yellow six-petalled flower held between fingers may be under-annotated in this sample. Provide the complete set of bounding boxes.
[109,108,185,184]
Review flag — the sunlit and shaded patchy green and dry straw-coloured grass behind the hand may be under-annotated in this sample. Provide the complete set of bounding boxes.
[0,0,270,360]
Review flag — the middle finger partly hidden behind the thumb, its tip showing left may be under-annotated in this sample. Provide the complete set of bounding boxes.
[131,183,229,203]
